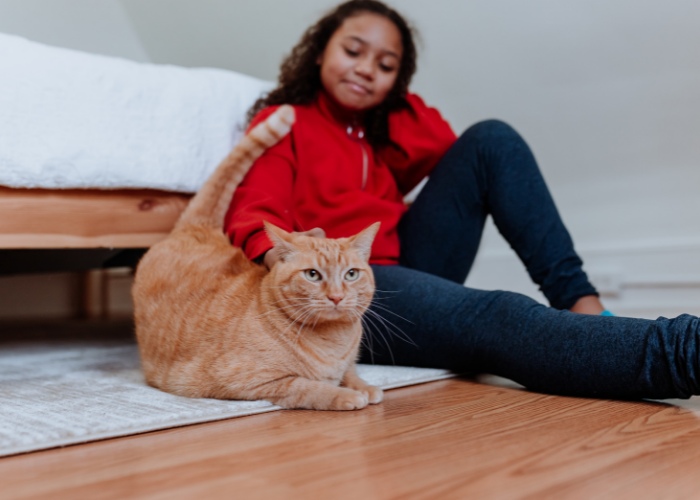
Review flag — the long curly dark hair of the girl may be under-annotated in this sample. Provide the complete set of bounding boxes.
[248,0,417,146]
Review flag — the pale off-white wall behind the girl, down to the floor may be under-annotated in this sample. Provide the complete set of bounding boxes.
[120,0,700,315]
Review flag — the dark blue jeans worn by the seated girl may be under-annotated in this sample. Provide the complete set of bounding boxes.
[361,121,700,399]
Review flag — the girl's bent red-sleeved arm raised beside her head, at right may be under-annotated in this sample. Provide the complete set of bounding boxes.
[380,94,457,194]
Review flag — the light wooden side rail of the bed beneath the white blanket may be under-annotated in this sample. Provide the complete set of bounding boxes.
[0,187,190,250]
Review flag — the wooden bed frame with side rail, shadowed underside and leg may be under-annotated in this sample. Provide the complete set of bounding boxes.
[0,186,191,319]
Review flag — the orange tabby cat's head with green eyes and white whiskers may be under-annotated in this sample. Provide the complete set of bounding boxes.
[265,222,379,324]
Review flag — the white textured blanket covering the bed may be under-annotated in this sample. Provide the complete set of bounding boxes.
[0,34,271,192]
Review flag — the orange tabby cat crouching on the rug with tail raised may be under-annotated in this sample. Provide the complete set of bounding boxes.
[132,106,383,410]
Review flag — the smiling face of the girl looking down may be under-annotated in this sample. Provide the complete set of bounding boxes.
[318,12,403,111]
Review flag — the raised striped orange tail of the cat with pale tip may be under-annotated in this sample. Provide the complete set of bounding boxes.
[175,104,294,229]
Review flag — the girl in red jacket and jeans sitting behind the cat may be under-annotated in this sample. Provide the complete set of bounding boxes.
[226,0,700,398]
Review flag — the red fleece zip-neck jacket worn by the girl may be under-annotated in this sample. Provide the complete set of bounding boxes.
[225,93,456,264]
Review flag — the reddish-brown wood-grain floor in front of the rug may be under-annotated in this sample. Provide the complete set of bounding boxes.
[0,366,700,500]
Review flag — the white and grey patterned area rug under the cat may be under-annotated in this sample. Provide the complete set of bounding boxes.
[0,328,451,456]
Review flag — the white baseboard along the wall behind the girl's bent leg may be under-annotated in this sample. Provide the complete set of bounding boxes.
[467,238,700,318]
